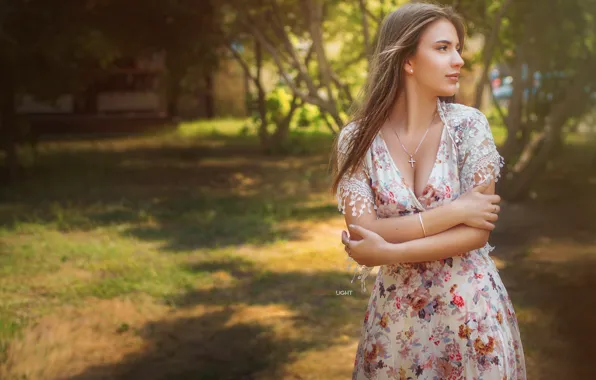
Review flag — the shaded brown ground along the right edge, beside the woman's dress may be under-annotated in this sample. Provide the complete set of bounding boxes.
[491,179,596,380]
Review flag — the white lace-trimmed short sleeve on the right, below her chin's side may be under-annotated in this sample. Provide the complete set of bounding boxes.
[458,110,504,193]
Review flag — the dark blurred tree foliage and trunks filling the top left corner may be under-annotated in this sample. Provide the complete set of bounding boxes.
[0,0,222,180]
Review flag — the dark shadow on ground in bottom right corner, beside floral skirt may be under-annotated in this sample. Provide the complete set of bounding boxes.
[500,252,596,380]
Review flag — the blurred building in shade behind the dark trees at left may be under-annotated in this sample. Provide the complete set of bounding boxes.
[17,54,247,132]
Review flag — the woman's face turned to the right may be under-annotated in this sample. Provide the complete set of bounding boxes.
[405,20,464,96]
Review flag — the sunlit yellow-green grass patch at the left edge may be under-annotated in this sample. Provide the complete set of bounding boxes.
[0,228,207,339]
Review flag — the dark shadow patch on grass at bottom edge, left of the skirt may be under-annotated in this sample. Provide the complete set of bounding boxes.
[70,310,294,380]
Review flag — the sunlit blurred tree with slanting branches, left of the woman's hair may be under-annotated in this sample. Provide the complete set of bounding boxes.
[223,0,399,150]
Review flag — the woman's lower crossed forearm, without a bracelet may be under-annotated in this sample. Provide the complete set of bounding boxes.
[379,225,490,265]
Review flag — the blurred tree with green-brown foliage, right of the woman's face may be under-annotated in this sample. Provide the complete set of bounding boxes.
[436,0,596,200]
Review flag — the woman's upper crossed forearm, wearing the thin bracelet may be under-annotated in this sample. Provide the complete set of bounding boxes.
[354,203,463,243]
